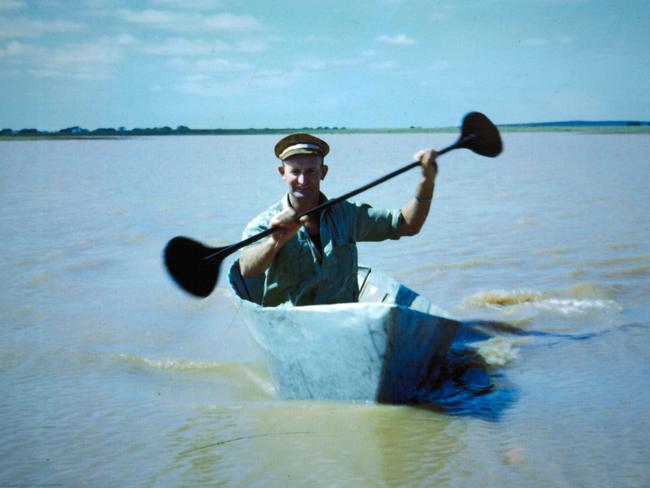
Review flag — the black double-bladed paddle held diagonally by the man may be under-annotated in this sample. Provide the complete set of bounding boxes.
[164,112,503,298]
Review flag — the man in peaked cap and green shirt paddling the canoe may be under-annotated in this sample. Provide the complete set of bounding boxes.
[239,134,438,306]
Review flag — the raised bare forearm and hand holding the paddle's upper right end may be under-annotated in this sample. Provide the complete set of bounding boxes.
[399,149,438,236]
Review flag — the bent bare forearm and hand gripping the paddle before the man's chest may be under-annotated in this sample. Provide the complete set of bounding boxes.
[239,209,306,278]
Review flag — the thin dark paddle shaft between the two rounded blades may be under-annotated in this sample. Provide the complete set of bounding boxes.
[203,134,476,262]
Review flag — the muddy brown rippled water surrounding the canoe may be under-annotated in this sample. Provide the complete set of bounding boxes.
[0,133,650,487]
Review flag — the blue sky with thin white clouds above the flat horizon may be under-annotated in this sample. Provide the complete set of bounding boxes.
[0,0,650,130]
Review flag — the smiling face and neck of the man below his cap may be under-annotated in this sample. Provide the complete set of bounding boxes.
[278,154,327,202]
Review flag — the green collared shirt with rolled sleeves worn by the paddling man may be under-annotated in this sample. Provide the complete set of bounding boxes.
[243,195,401,307]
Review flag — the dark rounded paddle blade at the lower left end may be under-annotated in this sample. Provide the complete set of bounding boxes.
[164,236,221,298]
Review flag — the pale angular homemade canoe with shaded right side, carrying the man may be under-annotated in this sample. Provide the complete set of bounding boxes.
[229,261,461,403]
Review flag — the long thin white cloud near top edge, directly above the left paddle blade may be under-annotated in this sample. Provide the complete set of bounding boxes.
[116,9,261,32]
